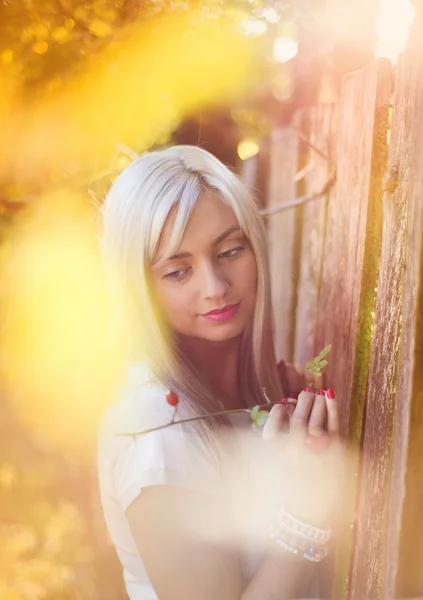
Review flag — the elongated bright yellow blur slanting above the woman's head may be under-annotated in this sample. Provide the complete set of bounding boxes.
[0,14,254,190]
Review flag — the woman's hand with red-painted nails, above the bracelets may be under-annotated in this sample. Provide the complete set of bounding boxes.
[263,391,346,527]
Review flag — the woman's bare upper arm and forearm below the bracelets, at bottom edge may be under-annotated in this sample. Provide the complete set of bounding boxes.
[126,486,315,600]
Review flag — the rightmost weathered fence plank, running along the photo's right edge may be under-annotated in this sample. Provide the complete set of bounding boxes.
[351,24,423,598]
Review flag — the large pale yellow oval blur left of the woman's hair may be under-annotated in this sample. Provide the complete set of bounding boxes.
[0,192,131,452]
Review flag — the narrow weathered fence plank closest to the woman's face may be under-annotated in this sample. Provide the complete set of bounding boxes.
[267,127,300,361]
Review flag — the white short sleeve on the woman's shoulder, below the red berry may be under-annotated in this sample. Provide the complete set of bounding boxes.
[102,382,218,511]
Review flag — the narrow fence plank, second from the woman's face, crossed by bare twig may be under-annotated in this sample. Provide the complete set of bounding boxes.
[294,104,334,365]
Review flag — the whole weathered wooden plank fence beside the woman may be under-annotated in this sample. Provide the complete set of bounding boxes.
[245,15,423,600]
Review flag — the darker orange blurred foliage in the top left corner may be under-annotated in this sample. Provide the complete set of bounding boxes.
[0,0,274,96]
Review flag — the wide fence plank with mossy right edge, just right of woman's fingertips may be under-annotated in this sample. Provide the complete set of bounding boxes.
[316,60,392,600]
